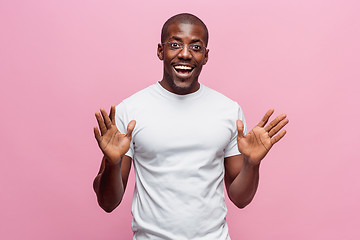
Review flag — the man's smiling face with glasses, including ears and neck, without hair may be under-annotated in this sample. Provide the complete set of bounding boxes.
[158,23,209,94]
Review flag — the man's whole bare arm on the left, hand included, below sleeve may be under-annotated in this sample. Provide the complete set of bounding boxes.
[93,106,135,212]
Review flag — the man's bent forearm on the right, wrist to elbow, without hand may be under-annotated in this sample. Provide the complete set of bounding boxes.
[228,159,260,208]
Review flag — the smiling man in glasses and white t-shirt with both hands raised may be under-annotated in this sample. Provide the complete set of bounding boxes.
[94,14,288,240]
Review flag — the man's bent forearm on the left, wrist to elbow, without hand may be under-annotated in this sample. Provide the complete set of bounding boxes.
[94,158,124,212]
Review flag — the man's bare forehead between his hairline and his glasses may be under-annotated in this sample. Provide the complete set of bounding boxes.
[166,23,205,42]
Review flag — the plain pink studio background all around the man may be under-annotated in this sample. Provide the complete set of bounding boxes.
[0,0,360,240]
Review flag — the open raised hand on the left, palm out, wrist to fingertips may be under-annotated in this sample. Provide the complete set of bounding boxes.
[94,106,136,164]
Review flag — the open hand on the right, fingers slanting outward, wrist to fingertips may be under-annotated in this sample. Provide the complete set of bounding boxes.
[236,109,289,165]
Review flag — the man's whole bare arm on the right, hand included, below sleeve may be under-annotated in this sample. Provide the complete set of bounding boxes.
[225,110,289,208]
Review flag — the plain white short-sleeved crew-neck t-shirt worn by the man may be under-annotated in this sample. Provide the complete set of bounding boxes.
[116,83,246,240]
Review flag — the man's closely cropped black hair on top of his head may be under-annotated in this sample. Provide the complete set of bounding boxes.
[161,13,209,46]
